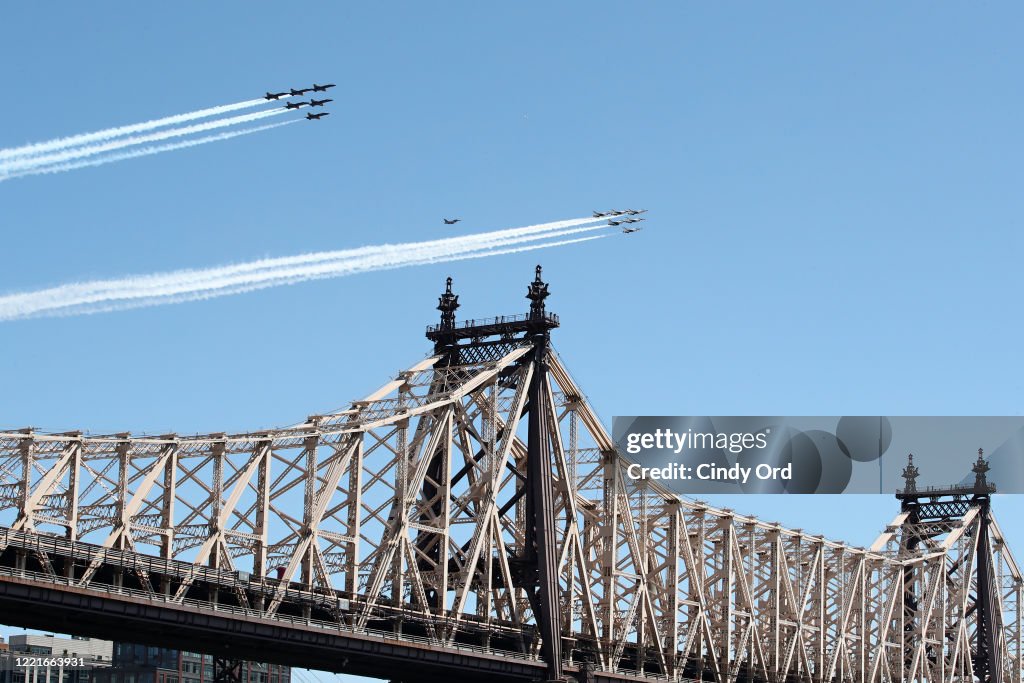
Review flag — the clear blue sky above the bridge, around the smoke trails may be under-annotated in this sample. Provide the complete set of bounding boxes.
[0,2,1024,679]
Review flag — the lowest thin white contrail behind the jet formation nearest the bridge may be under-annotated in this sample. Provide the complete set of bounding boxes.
[28,233,611,322]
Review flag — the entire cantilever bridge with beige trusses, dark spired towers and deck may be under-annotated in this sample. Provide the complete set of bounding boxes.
[0,267,1022,683]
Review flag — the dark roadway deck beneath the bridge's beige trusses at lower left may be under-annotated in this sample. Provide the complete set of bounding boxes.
[0,529,665,683]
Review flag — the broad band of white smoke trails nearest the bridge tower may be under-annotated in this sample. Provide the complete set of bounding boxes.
[0,218,608,322]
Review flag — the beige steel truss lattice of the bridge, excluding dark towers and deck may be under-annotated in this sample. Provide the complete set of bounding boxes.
[0,348,1022,683]
